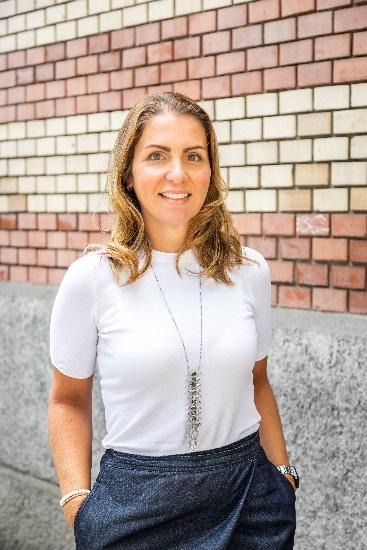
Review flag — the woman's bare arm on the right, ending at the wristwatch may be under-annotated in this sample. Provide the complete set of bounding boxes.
[252,357,296,489]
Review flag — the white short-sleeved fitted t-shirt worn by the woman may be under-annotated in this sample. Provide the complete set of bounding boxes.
[50,246,271,455]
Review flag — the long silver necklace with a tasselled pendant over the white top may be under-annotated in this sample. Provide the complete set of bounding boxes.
[151,266,203,451]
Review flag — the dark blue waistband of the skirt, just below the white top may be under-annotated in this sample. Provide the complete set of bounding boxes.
[104,429,261,471]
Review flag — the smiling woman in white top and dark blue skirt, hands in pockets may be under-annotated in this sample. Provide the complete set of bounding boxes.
[49,92,298,550]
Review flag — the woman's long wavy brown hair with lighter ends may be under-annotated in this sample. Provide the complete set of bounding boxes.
[83,92,260,285]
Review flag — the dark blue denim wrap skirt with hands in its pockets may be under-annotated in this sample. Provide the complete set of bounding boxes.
[74,430,296,550]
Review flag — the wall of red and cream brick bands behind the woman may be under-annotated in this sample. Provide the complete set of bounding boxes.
[0,0,367,313]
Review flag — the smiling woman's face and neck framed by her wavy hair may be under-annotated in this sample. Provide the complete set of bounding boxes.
[130,113,211,246]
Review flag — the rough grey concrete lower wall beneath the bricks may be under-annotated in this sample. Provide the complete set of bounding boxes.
[0,281,367,550]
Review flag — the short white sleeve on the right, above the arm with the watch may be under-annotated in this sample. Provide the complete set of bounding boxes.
[246,248,271,361]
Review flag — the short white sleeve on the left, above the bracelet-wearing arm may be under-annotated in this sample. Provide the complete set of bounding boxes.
[50,254,98,378]
